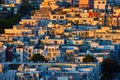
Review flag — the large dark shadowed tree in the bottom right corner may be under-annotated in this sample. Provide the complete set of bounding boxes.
[101,58,120,80]
